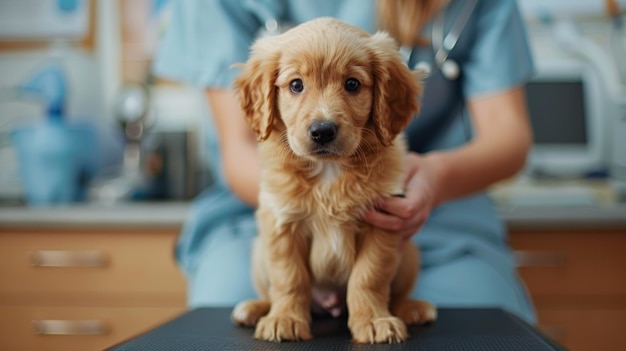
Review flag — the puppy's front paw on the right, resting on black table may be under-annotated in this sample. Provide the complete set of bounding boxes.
[350,317,408,344]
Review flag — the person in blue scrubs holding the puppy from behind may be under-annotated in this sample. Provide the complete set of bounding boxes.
[154,0,535,323]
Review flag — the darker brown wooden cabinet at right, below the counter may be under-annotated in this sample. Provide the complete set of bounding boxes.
[510,229,626,351]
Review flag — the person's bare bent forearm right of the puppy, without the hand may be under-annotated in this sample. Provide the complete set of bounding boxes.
[425,90,532,204]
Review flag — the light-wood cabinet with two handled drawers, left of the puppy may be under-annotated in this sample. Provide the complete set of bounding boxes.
[0,227,186,351]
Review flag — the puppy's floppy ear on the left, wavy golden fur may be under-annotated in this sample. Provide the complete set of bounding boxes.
[234,38,280,141]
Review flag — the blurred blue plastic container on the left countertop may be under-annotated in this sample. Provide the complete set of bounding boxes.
[12,62,98,205]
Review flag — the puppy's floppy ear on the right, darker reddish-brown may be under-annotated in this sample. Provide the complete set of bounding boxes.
[369,32,423,145]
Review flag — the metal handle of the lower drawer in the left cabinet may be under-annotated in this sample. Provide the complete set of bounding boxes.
[32,319,109,335]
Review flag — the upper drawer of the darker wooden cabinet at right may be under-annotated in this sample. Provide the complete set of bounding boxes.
[510,231,626,296]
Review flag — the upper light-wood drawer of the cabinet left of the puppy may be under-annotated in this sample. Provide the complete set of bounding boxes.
[0,230,185,295]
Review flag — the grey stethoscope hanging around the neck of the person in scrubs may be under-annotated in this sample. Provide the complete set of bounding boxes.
[400,0,478,80]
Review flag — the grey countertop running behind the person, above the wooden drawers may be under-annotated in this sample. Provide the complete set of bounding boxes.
[0,202,626,229]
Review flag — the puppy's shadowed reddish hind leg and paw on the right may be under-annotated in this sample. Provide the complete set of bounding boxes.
[390,243,437,324]
